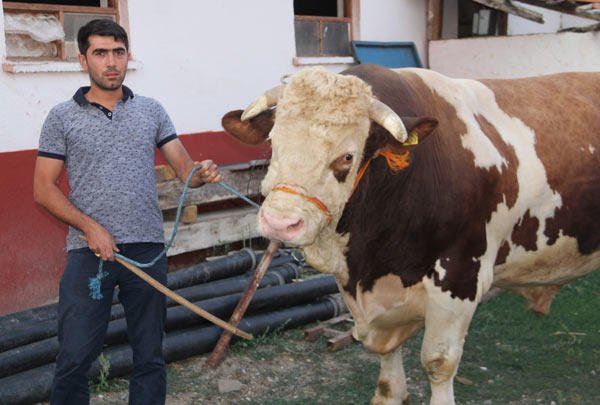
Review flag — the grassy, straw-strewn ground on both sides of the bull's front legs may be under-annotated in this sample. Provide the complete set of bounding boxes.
[95,271,600,405]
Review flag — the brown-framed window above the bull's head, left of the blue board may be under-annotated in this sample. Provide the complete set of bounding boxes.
[294,0,353,57]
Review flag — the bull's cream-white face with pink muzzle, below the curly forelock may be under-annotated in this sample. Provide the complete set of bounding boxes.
[258,112,370,246]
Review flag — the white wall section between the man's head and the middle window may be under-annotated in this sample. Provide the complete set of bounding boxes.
[128,0,295,137]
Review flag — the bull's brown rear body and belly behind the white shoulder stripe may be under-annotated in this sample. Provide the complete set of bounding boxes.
[482,73,600,285]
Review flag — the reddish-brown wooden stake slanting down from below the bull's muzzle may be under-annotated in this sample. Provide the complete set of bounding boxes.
[206,240,281,368]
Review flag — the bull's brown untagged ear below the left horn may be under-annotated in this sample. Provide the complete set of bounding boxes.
[221,110,275,145]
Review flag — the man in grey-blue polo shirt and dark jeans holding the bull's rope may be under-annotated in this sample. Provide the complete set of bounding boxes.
[34,20,221,405]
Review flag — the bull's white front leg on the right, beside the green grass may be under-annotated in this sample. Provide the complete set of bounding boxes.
[421,279,477,405]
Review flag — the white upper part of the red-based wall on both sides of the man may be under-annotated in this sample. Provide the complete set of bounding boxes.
[0,0,295,152]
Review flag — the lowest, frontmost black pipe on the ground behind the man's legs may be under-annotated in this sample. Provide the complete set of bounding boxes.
[0,296,344,405]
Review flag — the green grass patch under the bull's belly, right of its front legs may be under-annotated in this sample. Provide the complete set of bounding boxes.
[455,272,600,404]
